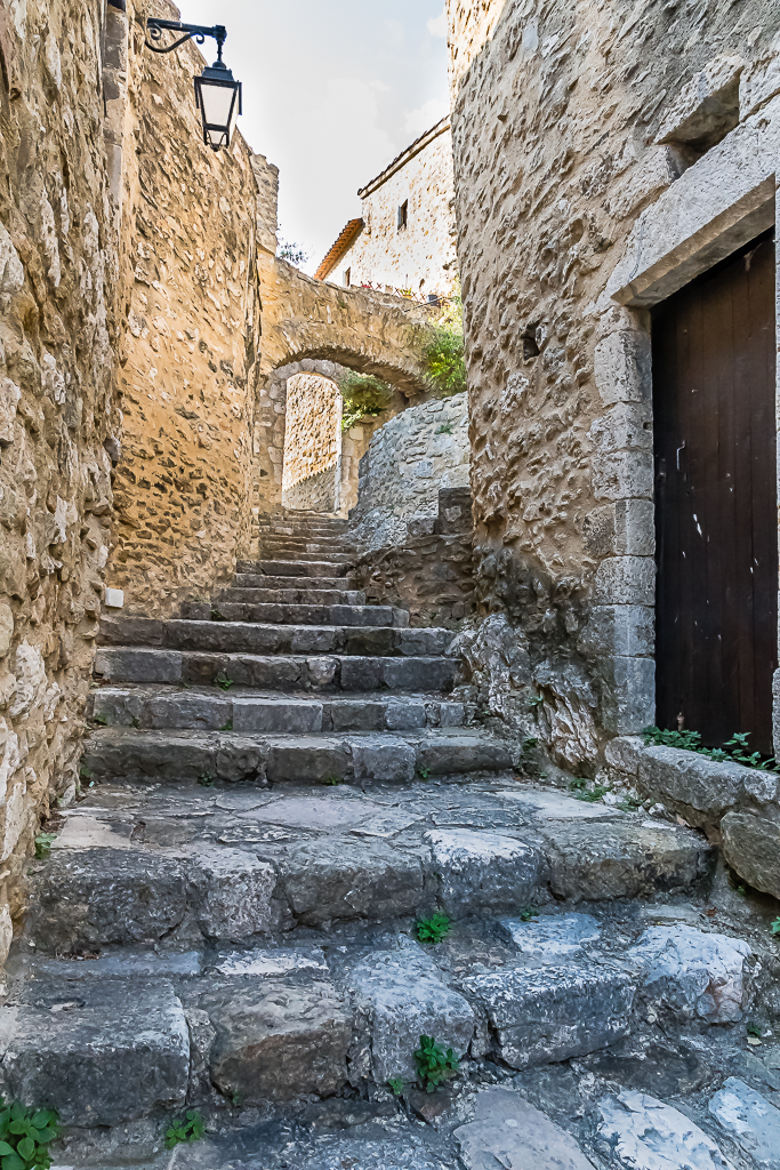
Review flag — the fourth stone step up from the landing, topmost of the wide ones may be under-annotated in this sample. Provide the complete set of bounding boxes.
[101,610,454,658]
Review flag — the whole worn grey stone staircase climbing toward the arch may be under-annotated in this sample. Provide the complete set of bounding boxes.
[0,515,780,1170]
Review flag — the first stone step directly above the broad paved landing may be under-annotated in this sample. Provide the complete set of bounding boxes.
[83,725,512,785]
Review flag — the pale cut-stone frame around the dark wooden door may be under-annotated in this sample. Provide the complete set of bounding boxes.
[591,97,780,752]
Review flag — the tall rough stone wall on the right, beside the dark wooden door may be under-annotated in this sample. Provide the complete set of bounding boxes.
[448,0,780,766]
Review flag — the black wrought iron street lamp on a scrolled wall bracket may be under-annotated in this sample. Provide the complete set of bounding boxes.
[146,16,241,151]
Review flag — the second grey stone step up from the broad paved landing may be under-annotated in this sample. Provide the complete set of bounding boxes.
[90,686,467,735]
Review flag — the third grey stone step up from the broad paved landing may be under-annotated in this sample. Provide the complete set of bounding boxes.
[95,645,457,693]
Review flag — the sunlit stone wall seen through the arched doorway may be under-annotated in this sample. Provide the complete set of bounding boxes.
[282,373,343,511]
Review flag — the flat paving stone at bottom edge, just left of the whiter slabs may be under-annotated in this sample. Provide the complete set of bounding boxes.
[455,1088,593,1170]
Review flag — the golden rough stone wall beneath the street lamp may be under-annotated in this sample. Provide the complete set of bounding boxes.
[109,0,264,615]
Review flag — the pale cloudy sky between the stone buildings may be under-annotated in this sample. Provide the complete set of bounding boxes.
[178,0,448,270]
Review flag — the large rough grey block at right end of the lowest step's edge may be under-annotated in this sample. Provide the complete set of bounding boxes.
[463,958,634,1068]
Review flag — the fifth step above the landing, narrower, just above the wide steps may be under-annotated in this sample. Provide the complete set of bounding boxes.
[182,600,409,629]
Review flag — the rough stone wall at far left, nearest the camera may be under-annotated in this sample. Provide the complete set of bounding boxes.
[0,0,117,963]
